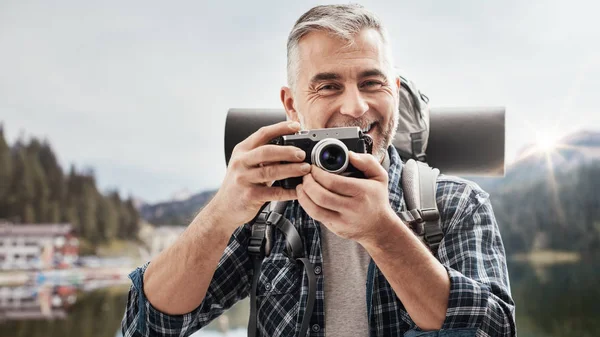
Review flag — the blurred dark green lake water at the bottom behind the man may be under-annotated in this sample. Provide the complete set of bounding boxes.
[0,257,600,337]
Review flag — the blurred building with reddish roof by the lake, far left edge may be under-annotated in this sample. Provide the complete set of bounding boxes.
[0,223,79,270]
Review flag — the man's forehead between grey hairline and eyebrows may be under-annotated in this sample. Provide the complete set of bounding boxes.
[298,29,387,81]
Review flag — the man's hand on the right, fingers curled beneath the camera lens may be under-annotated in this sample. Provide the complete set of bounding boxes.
[296,152,396,244]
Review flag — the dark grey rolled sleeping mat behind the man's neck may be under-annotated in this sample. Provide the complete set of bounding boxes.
[225,107,505,177]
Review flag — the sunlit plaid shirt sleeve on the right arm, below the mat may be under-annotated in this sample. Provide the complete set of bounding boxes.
[438,183,516,336]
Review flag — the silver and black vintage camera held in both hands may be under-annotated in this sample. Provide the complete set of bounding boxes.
[270,127,373,189]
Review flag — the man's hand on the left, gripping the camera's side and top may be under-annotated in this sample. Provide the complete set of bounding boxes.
[211,121,310,232]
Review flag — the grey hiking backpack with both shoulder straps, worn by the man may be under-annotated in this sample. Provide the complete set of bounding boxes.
[248,75,443,337]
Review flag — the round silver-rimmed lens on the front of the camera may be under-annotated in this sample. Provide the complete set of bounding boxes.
[312,138,348,173]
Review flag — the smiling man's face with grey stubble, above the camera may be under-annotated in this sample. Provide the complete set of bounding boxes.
[281,29,399,160]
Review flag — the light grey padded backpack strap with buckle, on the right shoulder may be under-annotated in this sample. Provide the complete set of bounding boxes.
[400,159,444,255]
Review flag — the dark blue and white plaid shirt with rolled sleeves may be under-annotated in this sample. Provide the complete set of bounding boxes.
[122,146,516,337]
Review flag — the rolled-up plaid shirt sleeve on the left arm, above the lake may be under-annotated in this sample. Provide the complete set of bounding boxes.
[121,225,253,337]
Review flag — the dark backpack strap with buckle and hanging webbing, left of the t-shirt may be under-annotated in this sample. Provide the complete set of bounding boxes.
[248,201,317,337]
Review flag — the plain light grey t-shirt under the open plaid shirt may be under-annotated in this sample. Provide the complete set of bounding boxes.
[320,152,389,337]
